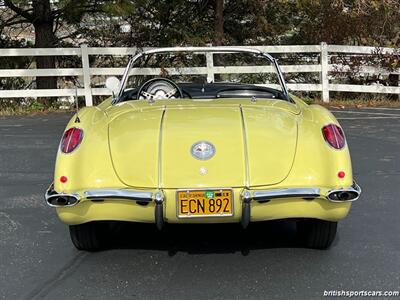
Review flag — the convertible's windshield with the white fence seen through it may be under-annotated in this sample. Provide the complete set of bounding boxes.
[117,47,289,102]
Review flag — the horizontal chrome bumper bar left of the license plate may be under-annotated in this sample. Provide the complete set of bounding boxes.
[85,189,153,202]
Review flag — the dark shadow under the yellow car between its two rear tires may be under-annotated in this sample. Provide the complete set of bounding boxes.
[105,220,302,256]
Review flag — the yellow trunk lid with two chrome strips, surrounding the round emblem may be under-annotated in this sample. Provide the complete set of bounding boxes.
[109,101,297,188]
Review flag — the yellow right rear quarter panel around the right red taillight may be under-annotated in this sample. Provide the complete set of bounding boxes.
[276,97,353,188]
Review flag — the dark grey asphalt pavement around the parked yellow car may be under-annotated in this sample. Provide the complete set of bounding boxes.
[0,109,400,299]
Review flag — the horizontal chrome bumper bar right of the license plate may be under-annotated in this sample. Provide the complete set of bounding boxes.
[252,188,320,201]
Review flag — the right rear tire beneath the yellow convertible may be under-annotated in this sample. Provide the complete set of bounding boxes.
[297,219,337,249]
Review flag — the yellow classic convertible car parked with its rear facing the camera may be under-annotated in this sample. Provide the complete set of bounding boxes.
[45,47,361,251]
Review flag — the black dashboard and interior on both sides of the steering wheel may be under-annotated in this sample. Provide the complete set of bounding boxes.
[118,82,287,102]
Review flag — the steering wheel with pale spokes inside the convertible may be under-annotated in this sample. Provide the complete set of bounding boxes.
[136,78,183,100]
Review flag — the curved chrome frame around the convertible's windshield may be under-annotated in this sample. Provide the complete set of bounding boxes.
[113,46,290,103]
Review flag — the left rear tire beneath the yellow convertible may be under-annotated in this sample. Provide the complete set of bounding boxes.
[69,222,107,251]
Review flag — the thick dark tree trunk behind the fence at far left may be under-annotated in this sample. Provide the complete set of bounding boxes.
[32,0,57,106]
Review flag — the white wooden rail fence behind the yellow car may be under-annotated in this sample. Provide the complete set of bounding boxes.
[0,43,400,106]
